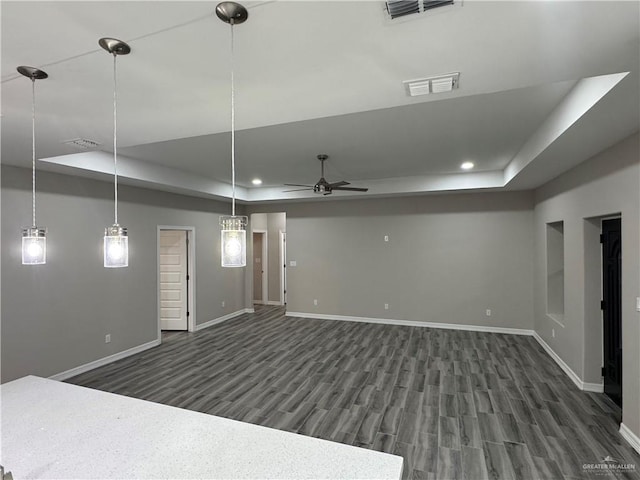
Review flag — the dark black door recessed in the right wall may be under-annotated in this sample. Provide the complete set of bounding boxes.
[601,218,622,407]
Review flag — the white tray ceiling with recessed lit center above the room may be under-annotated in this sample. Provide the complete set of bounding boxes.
[0,0,640,201]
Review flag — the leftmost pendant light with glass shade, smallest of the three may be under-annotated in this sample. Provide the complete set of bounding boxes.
[17,66,48,265]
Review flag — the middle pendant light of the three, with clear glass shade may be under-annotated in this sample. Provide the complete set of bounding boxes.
[98,38,131,268]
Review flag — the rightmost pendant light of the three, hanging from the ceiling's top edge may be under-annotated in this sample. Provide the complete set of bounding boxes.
[216,2,249,267]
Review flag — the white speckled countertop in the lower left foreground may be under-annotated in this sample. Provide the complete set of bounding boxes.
[0,376,402,480]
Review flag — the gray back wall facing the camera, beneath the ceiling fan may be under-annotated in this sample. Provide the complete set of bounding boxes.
[250,192,533,329]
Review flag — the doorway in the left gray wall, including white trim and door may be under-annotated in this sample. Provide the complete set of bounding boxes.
[158,227,195,332]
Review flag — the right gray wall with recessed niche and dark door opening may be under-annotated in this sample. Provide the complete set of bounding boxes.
[534,134,640,435]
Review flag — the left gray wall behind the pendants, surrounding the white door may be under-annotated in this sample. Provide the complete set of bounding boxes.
[1,166,245,382]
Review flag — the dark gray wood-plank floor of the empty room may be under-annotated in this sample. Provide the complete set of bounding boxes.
[68,307,640,480]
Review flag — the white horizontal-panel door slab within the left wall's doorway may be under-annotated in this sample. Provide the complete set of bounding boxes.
[160,230,188,330]
